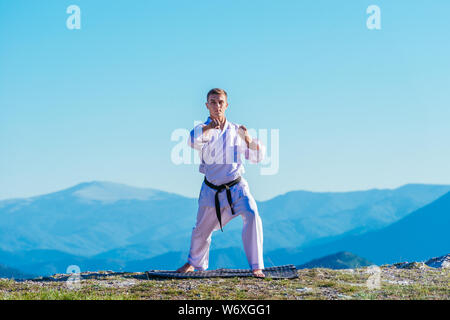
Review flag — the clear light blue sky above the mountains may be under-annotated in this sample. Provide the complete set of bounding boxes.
[0,0,450,200]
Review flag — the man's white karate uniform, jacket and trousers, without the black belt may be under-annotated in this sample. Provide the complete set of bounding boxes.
[188,117,266,270]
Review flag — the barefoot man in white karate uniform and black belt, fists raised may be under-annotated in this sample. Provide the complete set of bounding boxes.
[177,88,266,278]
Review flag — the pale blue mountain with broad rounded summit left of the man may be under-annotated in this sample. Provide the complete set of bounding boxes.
[0,181,197,256]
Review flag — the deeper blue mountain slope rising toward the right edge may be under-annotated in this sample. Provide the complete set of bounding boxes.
[268,192,450,265]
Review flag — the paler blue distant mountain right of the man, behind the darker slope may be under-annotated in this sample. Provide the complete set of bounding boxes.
[251,184,450,250]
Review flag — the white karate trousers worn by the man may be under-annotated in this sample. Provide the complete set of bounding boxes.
[188,177,264,270]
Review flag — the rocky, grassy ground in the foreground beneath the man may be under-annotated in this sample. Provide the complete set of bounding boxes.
[0,255,450,300]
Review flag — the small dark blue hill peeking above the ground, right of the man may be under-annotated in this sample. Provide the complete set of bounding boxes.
[297,251,373,269]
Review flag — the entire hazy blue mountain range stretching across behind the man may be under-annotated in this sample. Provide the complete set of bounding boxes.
[0,181,450,274]
